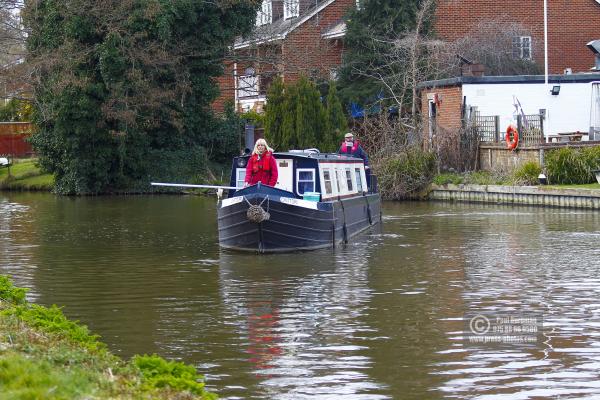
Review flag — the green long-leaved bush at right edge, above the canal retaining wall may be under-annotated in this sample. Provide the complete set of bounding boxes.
[545,146,600,184]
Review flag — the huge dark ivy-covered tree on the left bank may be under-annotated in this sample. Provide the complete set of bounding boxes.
[23,0,257,193]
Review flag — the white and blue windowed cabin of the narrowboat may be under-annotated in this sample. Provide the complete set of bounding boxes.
[229,150,369,201]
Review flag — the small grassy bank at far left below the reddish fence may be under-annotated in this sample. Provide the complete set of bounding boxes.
[0,158,54,191]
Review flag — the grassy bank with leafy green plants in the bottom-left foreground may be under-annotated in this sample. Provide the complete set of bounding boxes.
[0,275,216,400]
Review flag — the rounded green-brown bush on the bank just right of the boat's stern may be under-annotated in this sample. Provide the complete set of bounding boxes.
[376,148,436,199]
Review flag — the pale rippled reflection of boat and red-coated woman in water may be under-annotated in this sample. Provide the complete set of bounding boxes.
[219,227,389,399]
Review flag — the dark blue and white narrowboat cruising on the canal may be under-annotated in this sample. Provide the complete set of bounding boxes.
[217,149,381,253]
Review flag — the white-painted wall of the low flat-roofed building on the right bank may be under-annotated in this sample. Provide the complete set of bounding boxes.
[463,82,592,138]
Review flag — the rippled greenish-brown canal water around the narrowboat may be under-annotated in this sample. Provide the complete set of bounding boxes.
[0,193,600,399]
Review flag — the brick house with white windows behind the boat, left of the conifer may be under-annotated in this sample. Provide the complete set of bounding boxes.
[213,0,356,112]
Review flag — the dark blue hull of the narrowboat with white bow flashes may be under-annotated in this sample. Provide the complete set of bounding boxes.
[217,186,381,252]
